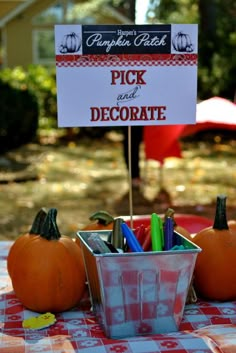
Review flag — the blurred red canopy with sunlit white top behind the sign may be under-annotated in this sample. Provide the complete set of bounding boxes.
[144,97,236,164]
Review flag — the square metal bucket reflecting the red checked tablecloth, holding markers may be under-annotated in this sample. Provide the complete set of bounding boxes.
[77,231,201,338]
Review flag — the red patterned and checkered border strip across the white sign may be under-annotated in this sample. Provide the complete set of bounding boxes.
[56,54,198,67]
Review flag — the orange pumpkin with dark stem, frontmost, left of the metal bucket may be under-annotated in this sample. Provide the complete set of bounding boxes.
[11,208,86,312]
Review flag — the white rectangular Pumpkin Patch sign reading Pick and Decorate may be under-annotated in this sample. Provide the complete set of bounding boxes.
[55,24,198,127]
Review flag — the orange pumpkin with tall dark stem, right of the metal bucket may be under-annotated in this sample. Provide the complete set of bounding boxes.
[194,195,236,301]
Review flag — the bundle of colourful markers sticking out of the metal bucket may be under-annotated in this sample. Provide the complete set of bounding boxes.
[86,213,188,254]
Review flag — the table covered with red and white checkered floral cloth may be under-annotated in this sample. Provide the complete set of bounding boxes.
[0,241,236,353]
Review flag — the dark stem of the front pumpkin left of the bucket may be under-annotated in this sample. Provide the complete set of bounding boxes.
[40,208,61,240]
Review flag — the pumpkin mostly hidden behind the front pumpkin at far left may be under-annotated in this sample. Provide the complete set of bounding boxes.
[7,208,47,277]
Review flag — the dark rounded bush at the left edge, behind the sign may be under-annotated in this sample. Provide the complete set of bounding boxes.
[0,79,38,153]
